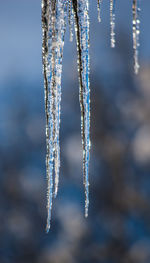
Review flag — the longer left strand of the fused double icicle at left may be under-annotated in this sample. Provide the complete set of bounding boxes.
[42,0,53,235]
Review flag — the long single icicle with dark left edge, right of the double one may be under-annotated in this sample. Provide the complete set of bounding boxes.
[73,0,90,217]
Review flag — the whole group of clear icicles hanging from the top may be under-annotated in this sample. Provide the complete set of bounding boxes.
[42,0,140,232]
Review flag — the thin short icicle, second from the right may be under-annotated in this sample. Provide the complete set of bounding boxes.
[110,0,116,48]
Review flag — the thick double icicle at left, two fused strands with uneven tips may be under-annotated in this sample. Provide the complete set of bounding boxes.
[42,0,67,232]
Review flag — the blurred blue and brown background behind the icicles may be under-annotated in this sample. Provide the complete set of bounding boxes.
[0,0,150,263]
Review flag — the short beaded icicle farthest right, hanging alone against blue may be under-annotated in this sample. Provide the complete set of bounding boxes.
[132,0,141,74]
